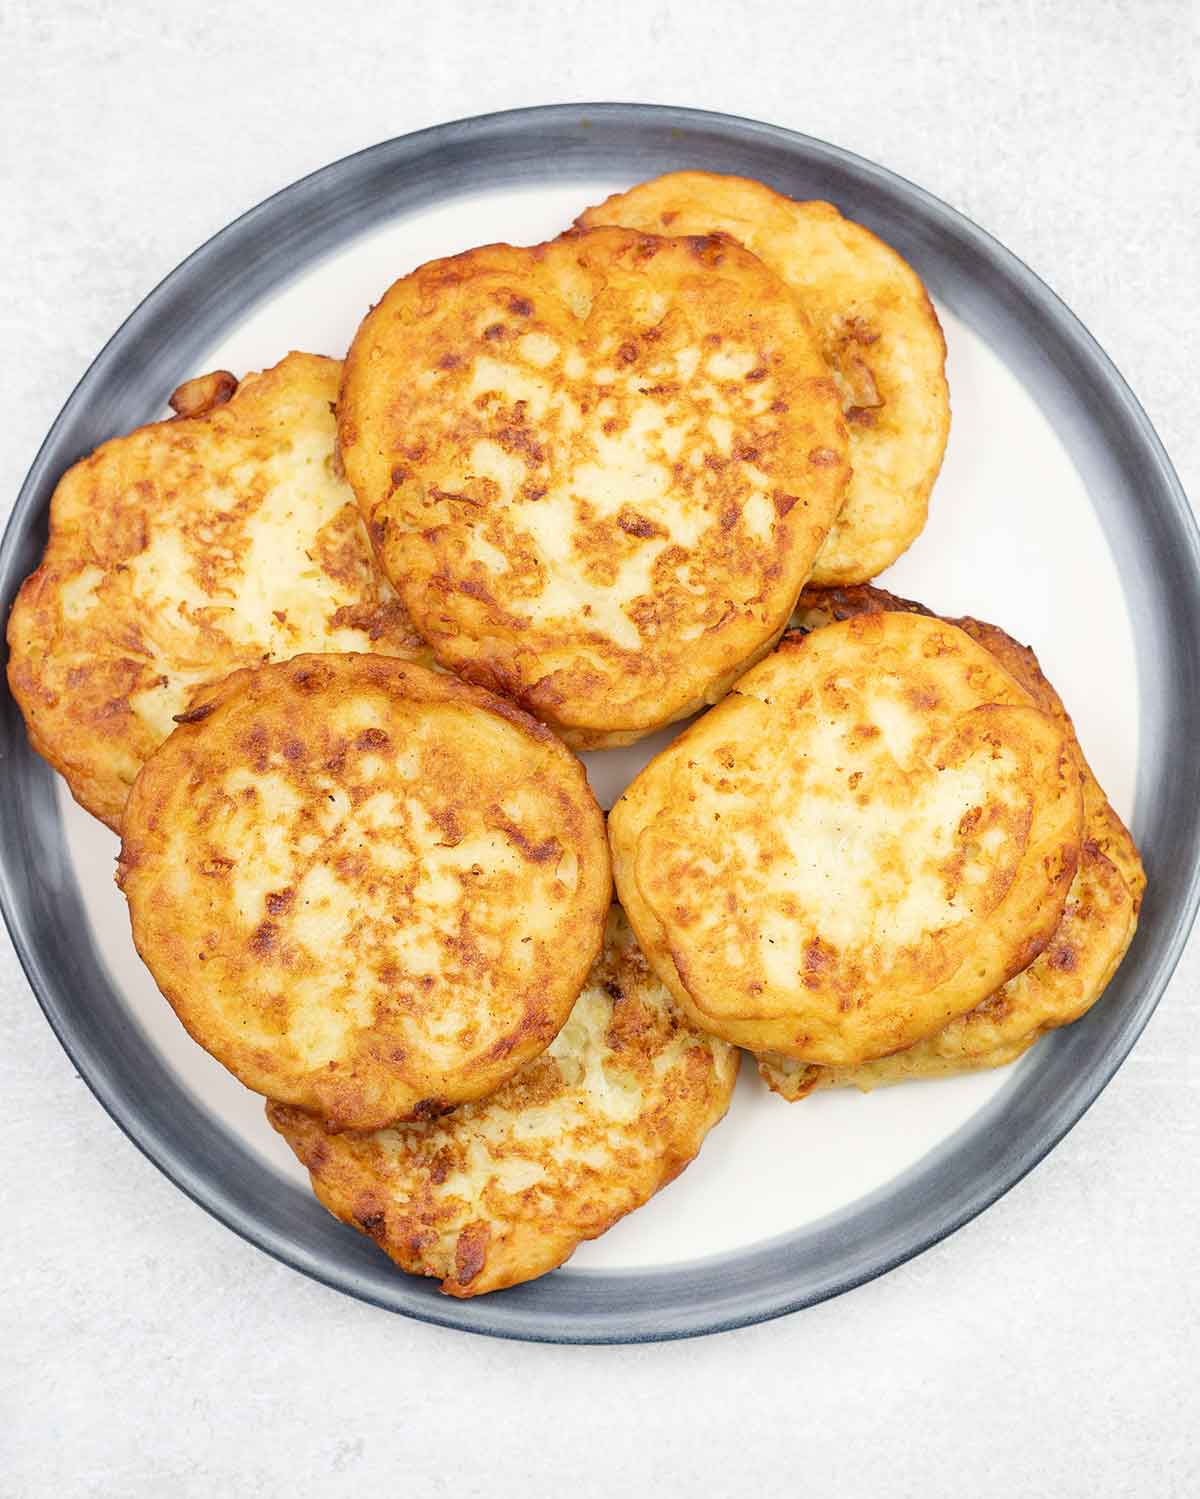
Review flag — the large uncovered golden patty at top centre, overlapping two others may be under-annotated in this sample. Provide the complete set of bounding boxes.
[339,229,848,748]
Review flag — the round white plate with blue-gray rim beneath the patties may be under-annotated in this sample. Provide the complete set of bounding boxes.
[0,105,1200,1342]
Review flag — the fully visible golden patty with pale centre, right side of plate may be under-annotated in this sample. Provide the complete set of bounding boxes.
[610,613,1082,1066]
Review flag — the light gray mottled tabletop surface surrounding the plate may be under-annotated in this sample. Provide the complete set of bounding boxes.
[0,0,1200,1499]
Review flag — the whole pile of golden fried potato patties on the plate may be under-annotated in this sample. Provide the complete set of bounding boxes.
[9,164,1142,1295]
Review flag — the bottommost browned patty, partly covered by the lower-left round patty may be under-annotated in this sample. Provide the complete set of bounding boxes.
[267,907,737,1297]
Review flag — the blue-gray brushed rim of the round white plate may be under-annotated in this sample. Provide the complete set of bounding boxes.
[0,103,1200,1343]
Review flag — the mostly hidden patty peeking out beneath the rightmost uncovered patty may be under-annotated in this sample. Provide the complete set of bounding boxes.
[758,588,1146,1100]
